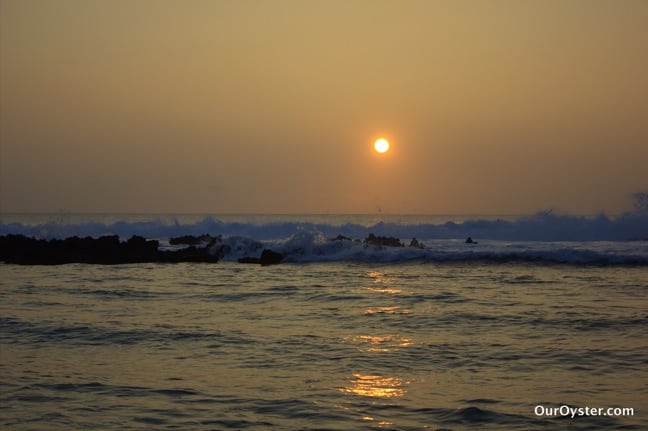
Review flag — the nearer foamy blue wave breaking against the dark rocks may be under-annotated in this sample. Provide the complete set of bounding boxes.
[212,231,648,265]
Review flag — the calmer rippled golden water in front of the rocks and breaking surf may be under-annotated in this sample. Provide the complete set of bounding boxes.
[0,262,648,431]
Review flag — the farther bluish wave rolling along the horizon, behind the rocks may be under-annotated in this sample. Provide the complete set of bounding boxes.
[0,212,648,241]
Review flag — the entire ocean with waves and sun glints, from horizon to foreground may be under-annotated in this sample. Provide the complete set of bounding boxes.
[0,213,648,430]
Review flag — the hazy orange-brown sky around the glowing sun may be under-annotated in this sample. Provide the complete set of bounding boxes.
[0,0,648,214]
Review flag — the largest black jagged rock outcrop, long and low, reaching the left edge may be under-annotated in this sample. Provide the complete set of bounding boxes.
[0,235,218,265]
